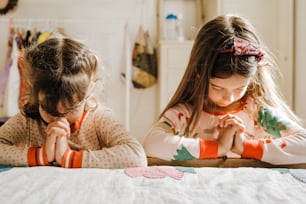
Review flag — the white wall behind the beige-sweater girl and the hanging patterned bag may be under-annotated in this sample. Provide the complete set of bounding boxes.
[0,0,157,141]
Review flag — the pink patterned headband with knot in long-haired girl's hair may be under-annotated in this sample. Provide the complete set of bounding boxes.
[220,37,264,62]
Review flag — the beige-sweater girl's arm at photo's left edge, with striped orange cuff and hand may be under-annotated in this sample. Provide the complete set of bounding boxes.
[0,114,69,166]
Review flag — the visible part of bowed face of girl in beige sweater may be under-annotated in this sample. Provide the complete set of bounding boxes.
[38,94,85,124]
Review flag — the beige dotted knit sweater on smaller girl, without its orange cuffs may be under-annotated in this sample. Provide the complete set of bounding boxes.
[0,106,147,168]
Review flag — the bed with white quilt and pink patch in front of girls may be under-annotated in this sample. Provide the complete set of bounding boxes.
[0,158,306,204]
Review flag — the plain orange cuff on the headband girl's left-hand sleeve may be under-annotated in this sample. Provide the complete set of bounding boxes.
[199,139,218,159]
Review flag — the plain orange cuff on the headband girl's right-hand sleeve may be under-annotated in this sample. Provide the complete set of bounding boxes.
[241,140,263,160]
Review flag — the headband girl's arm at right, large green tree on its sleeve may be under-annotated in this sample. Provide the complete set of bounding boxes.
[233,108,306,164]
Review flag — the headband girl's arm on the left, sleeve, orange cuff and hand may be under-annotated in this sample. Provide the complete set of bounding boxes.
[144,105,233,161]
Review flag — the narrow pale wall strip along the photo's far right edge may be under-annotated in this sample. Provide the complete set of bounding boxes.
[295,0,306,127]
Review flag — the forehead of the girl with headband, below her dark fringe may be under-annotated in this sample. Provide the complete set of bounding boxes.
[209,74,251,89]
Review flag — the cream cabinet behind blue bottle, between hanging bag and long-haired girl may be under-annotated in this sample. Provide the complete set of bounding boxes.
[157,0,202,114]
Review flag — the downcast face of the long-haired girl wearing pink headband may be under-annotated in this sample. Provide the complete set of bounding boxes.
[208,74,251,108]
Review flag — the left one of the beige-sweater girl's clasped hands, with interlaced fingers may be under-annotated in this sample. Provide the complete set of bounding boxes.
[45,118,70,163]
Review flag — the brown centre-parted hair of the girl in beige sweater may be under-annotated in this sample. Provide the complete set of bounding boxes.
[23,38,98,118]
